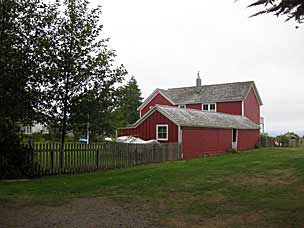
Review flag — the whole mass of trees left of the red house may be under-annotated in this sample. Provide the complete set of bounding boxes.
[0,0,142,178]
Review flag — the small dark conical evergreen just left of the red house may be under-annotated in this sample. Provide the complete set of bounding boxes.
[113,77,142,128]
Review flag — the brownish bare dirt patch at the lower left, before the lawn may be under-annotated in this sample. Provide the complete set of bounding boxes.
[0,198,162,228]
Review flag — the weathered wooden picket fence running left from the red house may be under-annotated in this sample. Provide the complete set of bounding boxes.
[23,142,182,176]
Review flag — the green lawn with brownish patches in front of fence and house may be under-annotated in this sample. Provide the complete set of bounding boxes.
[0,148,304,227]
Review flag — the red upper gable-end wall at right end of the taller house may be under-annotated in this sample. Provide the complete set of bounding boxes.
[244,88,260,124]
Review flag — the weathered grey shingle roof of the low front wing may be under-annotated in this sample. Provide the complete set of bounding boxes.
[129,105,260,129]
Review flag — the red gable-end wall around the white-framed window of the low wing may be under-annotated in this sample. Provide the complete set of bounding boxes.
[118,111,178,143]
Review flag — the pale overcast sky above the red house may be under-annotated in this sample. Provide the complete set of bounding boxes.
[91,0,304,134]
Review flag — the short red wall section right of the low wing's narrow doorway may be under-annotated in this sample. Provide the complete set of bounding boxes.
[237,130,260,150]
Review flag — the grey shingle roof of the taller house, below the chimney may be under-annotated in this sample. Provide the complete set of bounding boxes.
[160,81,255,104]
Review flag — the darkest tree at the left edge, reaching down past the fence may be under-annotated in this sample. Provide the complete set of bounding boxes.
[0,0,51,179]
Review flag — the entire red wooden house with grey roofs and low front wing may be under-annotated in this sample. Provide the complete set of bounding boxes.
[118,77,262,158]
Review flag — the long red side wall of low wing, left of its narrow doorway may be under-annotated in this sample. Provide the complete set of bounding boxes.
[182,128,232,159]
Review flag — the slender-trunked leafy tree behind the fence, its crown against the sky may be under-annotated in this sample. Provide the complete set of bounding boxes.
[41,0,126,153]
